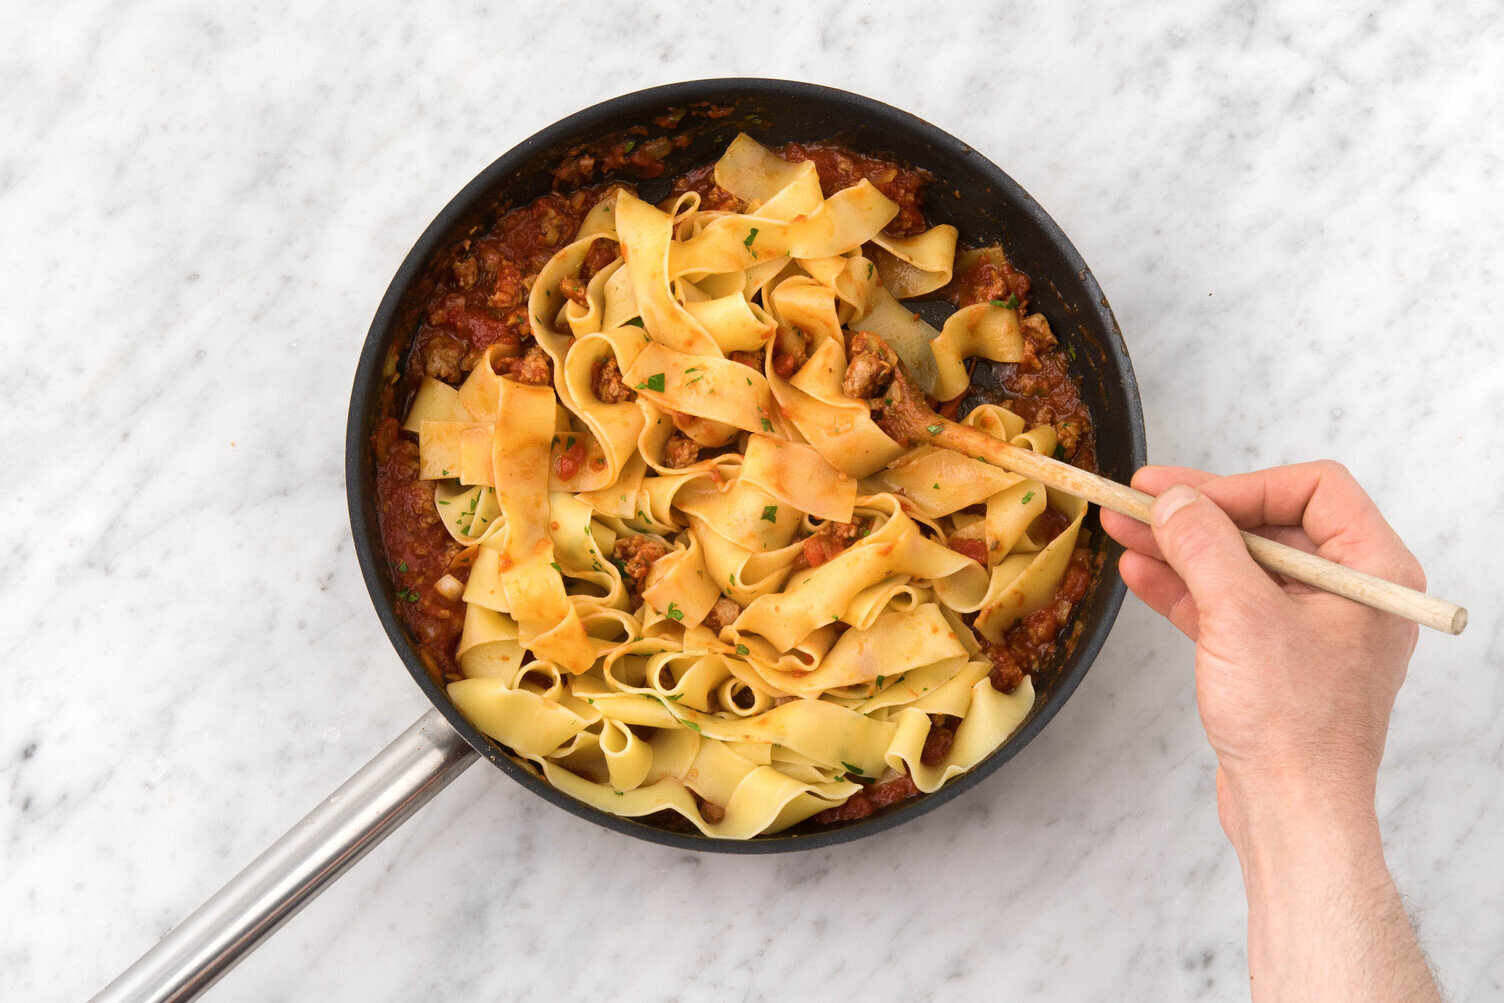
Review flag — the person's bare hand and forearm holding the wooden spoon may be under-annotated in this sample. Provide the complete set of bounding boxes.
[1102,462,1441,1000]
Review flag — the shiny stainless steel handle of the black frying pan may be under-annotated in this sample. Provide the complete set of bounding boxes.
[93,710,475,1003]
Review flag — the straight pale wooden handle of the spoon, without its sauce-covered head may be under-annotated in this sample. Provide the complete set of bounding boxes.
[929,421,1468,635]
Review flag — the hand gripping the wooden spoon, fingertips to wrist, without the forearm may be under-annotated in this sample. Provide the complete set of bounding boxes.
[1102,462,1426,850]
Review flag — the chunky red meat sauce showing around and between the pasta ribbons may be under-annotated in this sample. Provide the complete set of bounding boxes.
[371,142,1096,829]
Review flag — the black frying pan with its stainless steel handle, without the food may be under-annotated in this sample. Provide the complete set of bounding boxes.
[95,78,1145,1000]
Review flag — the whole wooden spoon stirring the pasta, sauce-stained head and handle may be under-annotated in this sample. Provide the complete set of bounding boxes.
[853,332,1468,635]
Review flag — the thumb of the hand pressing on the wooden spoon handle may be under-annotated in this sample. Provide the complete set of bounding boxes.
[1149,484,1278,611]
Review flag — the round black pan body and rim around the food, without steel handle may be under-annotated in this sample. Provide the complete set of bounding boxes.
[346,78,1146,853]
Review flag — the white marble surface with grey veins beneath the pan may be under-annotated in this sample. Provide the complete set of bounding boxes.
[0,0,1504,1000]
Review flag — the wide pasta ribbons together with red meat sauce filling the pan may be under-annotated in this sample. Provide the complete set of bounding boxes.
[373,135,1095,839]
